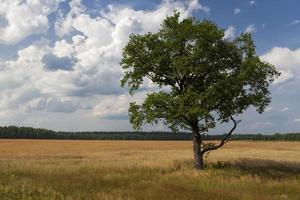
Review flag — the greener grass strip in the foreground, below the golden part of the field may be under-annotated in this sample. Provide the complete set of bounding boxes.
[0,160,300,200]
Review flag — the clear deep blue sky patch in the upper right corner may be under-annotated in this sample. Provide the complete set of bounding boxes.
[200,0,300,54]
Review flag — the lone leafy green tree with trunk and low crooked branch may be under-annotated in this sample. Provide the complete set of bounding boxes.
[121,12,279,169]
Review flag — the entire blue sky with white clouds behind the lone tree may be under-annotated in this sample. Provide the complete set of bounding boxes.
[0,0,300,133]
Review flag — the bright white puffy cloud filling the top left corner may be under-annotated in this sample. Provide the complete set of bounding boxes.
[0,0,60,45]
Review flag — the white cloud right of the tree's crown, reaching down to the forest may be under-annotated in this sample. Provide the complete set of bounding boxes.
[232,47,300,133]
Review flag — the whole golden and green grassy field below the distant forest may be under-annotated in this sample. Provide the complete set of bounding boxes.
[0,140,300,200]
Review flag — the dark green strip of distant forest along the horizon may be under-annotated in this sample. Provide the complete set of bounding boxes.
[0,126,300,141]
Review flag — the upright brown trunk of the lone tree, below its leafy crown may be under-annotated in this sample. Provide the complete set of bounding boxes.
[193,129,204,170]
